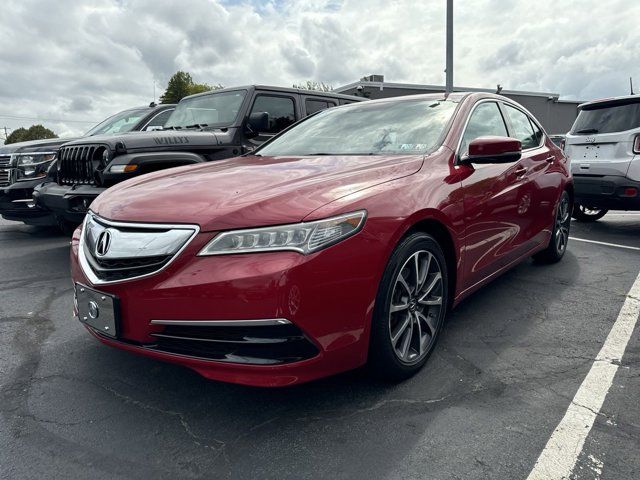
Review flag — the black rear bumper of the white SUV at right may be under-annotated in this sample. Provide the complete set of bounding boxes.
[573,174,640,210]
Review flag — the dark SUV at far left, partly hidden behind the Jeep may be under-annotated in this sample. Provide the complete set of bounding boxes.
[0,104,175,225]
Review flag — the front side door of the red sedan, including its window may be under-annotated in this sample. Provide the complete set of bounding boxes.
[457,100,527,288]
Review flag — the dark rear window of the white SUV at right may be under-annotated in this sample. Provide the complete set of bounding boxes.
[571,103,640,135]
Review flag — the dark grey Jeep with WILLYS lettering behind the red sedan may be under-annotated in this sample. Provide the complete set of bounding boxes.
[34,85,364,230]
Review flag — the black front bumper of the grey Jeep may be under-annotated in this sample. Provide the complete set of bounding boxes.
[33,182,106,223]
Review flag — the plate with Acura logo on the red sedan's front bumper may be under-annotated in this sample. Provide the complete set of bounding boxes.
[74,283,120,338]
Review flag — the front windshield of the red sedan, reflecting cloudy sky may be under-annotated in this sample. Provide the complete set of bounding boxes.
[259,98,457,156]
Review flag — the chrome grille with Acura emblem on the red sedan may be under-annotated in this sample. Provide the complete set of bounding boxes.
[80,213,197,283]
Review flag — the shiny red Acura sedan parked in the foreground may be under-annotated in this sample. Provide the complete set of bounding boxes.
[71,93,573,386]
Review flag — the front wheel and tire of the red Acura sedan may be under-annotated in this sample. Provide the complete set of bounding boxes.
[369,232,449,381]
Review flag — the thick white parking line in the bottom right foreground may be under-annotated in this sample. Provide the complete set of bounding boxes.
[527,275,640,480]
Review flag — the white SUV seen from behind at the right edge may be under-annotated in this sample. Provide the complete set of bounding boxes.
[565,95,640,222]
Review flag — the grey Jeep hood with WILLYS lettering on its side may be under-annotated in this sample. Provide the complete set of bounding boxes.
[65,129,230,152]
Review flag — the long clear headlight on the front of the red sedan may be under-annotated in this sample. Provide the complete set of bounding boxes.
[198,210,367,255]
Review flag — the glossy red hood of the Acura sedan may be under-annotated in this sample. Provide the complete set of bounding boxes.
[91,156,423,231]
